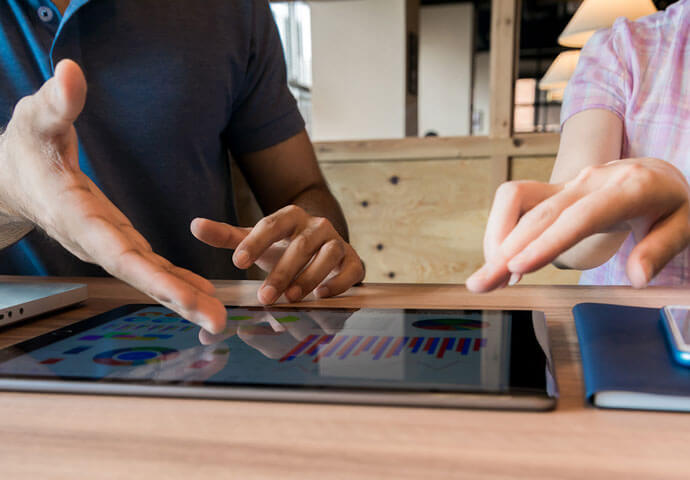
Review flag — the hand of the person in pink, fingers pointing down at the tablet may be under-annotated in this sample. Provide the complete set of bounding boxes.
[467,158,690,292]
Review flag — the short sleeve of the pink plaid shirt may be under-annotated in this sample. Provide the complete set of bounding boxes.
[561,19,631,128]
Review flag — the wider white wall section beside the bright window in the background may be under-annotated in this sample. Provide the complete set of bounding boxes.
[310,0,406,141]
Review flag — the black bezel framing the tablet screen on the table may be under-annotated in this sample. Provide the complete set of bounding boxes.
[0,304,557,399]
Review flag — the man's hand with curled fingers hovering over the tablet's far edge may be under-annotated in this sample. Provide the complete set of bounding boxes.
[191,205,364,305]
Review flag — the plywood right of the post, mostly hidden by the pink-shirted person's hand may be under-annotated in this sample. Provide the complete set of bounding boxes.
[510,157,580,285]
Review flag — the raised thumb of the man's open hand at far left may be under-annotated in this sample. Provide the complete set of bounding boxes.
[26,60,86,138]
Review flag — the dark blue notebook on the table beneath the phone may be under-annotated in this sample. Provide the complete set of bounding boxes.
[573,303,690,412]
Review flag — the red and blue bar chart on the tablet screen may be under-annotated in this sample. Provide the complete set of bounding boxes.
[280,335,487,362]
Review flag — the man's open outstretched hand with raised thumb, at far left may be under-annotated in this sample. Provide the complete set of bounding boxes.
[0,60,226,332]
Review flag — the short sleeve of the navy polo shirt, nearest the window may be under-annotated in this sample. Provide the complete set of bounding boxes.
[225,0,304,155]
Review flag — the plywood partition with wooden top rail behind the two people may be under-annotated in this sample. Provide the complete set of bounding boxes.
[233,135,579,284]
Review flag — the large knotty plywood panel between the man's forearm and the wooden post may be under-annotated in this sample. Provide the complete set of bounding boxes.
[322,159,492,283]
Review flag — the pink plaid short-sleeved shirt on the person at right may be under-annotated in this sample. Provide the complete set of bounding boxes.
[561,0,690,286]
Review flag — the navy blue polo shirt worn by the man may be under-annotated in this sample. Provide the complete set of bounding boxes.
[0,0,304,278]
